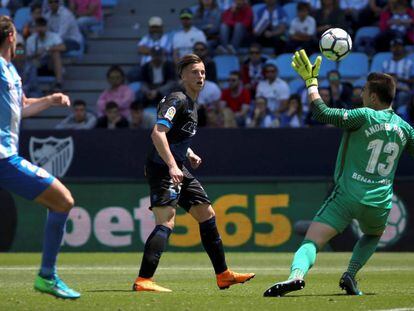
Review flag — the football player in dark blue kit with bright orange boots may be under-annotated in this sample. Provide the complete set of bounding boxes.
[133,54,254,292]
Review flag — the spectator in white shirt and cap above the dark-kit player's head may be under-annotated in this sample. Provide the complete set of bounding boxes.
[172,9,207,62]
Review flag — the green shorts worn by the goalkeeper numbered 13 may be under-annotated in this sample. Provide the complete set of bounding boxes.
[313,185,391,235]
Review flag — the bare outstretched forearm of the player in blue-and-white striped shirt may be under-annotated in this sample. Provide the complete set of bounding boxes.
[22,93,70,118]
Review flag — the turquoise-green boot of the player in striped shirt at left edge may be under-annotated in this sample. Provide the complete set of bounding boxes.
[34,274,80,299]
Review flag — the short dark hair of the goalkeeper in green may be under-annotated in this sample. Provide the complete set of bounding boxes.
[367,72,396,105]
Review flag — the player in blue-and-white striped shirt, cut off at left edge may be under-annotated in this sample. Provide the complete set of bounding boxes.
[0,16,80,299]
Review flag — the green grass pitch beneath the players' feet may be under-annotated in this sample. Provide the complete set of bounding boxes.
[0,252,414,311]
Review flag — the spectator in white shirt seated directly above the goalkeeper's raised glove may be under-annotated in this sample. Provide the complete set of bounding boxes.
[287,2,317,55]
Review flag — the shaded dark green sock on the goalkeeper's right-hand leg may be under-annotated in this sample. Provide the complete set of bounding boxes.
[347,234,381,277]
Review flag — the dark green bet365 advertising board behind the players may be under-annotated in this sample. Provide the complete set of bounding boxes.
[0,181,414,252]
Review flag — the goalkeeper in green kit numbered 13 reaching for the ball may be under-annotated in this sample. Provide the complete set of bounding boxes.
[264,50,414,297]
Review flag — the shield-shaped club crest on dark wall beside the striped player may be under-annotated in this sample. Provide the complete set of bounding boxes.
[29,136,74,177]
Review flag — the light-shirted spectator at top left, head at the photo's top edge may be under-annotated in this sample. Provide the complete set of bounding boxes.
[45,0,83,51]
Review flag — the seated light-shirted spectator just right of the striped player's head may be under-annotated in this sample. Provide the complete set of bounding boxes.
[26,17,66,89]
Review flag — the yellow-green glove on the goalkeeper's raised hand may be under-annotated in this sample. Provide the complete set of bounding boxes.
[292,50,322,87]
